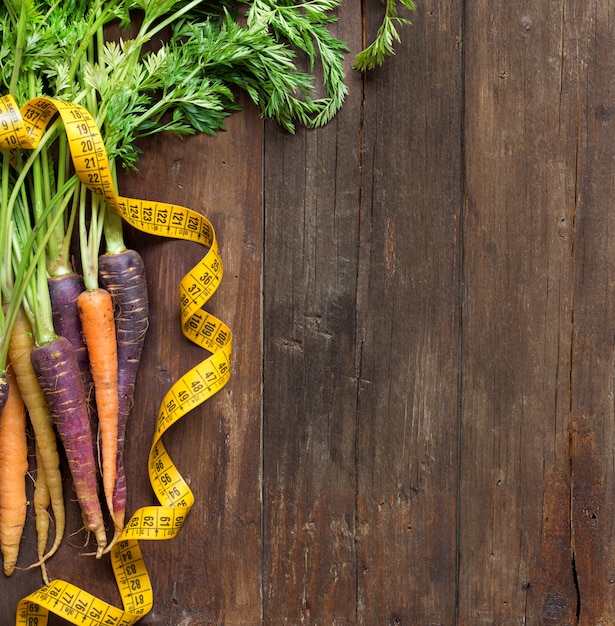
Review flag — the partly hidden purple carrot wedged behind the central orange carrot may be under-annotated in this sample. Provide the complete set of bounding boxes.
[48,273,96,416]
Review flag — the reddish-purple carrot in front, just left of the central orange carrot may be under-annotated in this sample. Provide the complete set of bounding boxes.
[30,337,107,557]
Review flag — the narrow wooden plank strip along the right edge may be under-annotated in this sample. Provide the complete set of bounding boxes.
[567,1,615,625]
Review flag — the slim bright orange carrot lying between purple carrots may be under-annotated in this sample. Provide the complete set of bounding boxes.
[77,289,121,536]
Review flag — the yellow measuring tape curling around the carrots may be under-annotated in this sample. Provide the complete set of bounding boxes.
[0,96,232,626]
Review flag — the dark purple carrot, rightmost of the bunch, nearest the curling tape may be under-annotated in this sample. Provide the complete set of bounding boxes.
[98,250,149,531]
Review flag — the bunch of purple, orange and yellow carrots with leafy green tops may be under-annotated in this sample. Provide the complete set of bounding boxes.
[0,0,412,580]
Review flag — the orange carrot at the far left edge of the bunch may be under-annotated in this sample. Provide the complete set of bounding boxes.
[0,358,28,576]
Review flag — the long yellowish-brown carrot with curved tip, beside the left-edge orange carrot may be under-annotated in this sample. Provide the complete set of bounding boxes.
[9,309,66,558]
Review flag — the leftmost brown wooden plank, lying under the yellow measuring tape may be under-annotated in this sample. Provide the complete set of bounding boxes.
[0,100,262,626]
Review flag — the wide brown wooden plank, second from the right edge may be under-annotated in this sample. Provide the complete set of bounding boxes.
[458,1,577,626]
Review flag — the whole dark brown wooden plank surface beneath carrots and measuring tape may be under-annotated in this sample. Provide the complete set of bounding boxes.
[0,0,615,626]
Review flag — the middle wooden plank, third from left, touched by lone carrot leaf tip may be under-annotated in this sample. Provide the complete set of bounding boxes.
[356,3,463,626]
